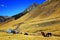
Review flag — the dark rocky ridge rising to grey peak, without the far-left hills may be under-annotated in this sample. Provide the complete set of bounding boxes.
[12,3,38,20]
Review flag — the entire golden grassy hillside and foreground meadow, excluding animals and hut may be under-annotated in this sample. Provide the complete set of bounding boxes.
[0,0,60,40]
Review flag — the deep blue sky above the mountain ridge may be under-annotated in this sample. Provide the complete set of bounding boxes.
[0,0,45,16]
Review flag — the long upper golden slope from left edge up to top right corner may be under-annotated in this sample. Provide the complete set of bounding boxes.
[0,0,60,30]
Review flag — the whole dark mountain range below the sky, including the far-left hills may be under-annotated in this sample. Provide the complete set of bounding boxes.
[0,3,38,24]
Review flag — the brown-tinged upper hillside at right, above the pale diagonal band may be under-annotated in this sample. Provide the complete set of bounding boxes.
[18,1,60,22]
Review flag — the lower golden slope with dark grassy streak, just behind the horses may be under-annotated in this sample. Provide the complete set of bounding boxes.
[20,18,60,33]
